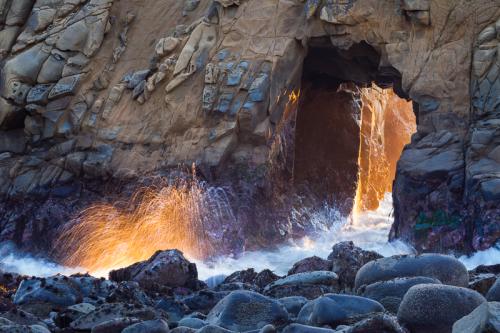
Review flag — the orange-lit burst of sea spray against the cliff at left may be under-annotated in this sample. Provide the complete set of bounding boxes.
[59,171,232,275]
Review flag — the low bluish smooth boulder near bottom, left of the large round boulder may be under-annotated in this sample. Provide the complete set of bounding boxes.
[297,294,385,327]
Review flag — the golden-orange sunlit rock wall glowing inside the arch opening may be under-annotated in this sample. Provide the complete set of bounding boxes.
[353,86,416,219]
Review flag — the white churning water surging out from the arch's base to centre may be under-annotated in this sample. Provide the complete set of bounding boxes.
[195,193,414,279]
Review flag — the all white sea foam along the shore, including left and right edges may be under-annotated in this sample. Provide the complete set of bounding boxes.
[0,194,500,278]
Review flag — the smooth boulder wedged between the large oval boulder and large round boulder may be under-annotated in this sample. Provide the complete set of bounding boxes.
[358,276,441,313]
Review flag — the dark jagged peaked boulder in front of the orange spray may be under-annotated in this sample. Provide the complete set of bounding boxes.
[109,250,198,289]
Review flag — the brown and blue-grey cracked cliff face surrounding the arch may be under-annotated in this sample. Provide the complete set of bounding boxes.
[0,0,500,249]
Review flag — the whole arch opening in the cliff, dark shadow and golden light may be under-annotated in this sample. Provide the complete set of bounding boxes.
[292,38,416,215]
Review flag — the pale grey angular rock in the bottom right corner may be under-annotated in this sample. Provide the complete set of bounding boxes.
[452,302,500,333]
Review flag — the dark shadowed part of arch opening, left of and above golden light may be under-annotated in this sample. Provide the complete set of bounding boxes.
[293,38,408,214]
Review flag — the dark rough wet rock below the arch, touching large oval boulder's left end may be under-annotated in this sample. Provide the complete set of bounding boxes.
[328,241,382,290]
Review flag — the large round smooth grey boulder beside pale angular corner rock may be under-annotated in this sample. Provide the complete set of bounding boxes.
[398,284,486,333]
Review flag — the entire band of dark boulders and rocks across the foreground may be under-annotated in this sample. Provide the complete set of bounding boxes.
[0,242,500,333]
